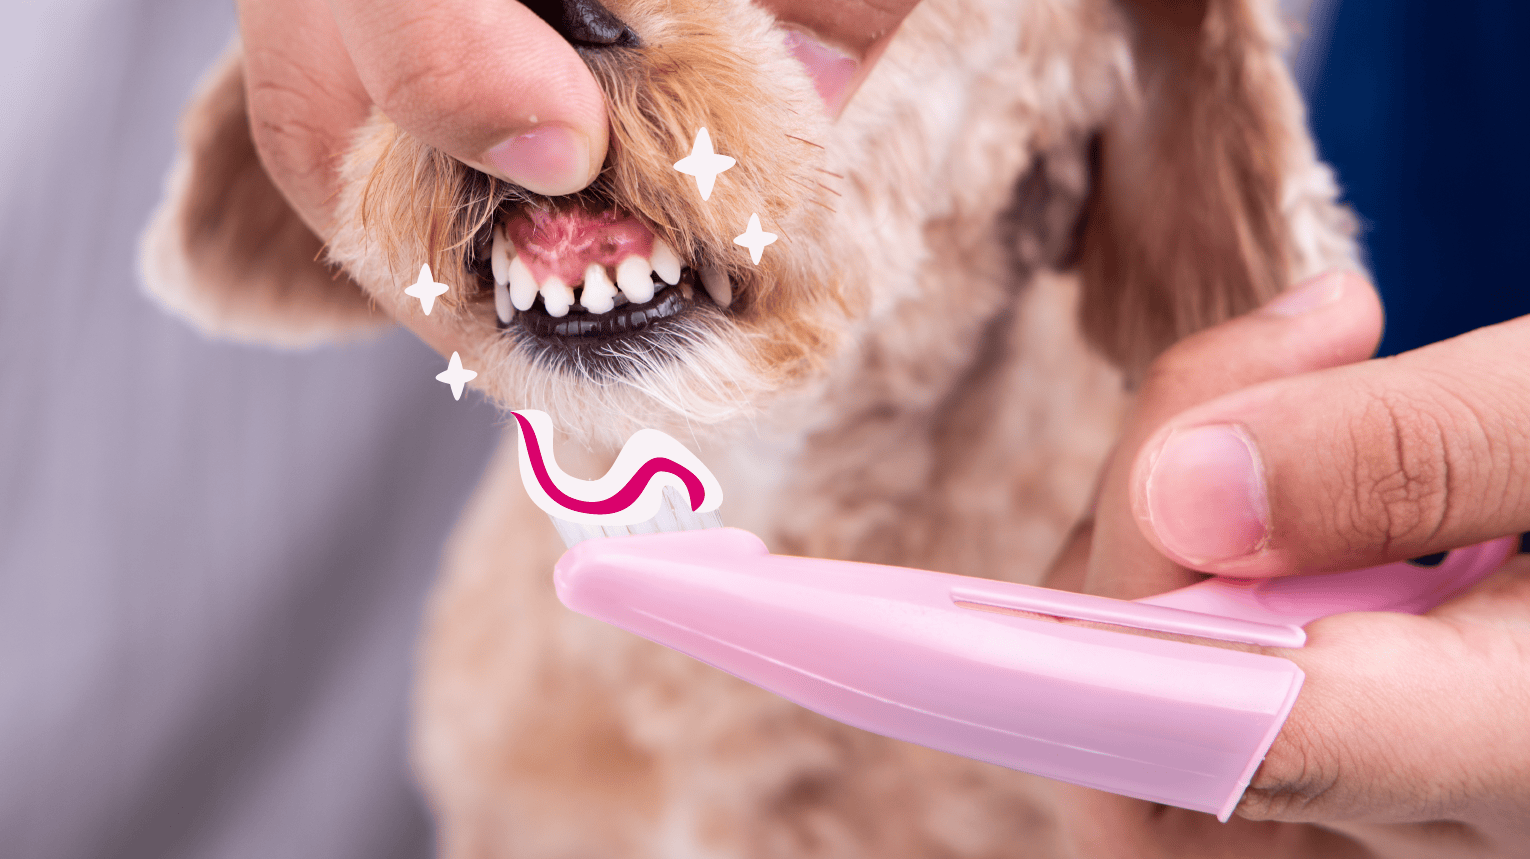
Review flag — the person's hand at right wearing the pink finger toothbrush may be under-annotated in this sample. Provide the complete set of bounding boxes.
[1050,274,1530,859]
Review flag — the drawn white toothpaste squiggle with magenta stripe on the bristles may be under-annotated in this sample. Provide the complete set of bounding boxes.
[511,409,722,528]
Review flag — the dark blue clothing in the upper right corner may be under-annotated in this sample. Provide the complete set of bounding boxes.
[1311,0,1530,355]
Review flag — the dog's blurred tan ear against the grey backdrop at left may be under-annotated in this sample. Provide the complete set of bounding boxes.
[139,40,387,346]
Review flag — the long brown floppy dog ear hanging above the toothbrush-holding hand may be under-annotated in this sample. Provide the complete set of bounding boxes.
[1079,0,1357,378]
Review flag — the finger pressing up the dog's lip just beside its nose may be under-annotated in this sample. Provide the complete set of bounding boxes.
[332,0,607,196]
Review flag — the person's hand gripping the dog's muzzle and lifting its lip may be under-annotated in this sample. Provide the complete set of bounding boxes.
[239,0,916,236]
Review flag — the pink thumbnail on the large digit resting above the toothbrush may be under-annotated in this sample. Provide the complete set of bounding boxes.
[1146,424,1270,563]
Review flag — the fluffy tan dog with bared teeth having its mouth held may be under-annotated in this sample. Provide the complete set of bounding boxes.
[144,0,1354,859]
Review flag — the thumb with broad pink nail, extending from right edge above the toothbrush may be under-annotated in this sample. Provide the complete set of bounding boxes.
[1132,309,1530,576]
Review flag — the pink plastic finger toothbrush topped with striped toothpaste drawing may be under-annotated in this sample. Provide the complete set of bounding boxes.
[516,412,1515,821]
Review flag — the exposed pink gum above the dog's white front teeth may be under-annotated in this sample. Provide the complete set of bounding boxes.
[505,208,653,285]
